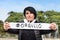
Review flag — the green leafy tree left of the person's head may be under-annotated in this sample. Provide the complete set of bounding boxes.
[6,11,23,22]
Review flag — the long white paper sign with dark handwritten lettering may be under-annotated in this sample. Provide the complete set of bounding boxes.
[9,23,50,30]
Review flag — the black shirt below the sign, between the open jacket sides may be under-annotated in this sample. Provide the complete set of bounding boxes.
[21,29,36,40]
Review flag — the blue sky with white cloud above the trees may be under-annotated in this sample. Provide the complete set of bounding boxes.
[0,0,60,21]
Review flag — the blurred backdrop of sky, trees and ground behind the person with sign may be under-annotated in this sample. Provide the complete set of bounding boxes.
[0,0,60,40]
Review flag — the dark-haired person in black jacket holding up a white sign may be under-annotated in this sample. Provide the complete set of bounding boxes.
[4,7,56,40]
